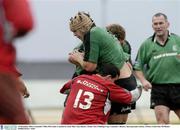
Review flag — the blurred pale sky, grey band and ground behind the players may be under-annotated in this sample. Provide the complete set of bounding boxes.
[16,0,180,124]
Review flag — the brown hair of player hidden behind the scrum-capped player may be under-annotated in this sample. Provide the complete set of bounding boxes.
[106,24,126,40]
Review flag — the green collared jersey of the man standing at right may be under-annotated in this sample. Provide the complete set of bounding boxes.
[133,34,180,84]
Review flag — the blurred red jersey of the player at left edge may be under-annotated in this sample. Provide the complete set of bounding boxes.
[0,0,33,76]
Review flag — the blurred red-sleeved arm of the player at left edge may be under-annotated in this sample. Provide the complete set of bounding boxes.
[3,0,34,43]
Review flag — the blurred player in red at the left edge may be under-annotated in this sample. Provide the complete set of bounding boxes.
[0,0,33,124]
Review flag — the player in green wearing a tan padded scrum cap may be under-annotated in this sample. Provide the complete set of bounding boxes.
[69,12,141,124]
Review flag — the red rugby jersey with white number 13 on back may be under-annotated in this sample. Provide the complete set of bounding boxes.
[60,75,132,124]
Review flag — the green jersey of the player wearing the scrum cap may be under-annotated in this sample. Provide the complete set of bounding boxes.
[83,27,125,73]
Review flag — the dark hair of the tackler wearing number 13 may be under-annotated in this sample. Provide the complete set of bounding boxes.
[99,64,120,78]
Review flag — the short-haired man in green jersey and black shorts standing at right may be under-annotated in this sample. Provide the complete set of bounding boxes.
[134,13,180,124]
